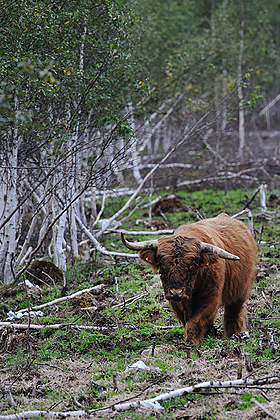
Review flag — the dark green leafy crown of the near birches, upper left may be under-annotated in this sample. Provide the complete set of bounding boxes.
[0,0,144,151]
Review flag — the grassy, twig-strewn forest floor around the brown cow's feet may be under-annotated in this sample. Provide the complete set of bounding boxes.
[0,184,280,420]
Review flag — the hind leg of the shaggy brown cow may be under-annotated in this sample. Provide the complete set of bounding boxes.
[224,300,247,337]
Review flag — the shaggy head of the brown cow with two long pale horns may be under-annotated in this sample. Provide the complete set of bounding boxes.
[121,234,239,301]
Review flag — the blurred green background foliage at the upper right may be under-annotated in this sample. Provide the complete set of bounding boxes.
[136,0,279,118]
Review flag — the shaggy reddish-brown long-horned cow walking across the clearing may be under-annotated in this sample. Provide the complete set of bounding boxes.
[122,213,257,344]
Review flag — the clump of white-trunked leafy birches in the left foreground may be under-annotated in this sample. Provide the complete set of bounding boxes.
[0,0,144,283]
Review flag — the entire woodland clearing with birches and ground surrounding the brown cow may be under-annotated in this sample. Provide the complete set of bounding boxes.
[0,0,280,420]
